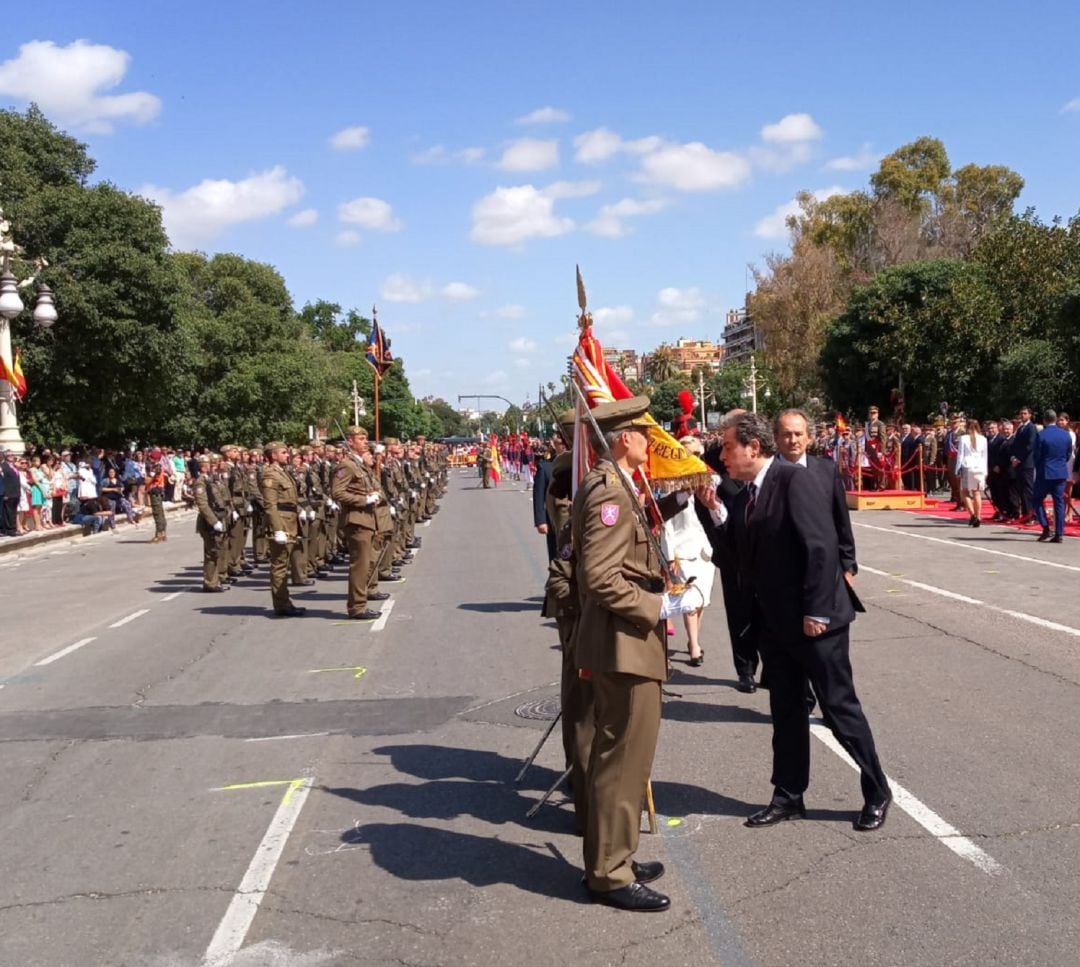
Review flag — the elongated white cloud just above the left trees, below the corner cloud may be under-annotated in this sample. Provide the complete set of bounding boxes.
[136,165,303,249]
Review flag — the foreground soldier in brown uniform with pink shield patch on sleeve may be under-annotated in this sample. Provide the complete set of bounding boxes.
[571,397,698,912]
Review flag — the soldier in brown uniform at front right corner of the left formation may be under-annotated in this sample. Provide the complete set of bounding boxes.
[330,427,380,621]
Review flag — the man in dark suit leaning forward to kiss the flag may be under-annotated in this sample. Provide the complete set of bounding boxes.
[697,414,892,831]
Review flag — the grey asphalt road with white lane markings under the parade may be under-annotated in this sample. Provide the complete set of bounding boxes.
[0,474,1080,967]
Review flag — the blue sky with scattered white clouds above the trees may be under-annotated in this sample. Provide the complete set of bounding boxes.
[0,0,1080,402]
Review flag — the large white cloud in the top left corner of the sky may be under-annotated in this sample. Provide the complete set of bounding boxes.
[0,40,161,134]
